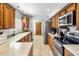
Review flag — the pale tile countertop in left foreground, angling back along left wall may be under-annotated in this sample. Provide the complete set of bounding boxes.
[0,32,32,56]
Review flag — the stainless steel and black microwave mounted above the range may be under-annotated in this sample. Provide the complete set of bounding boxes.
[59,11,76,26]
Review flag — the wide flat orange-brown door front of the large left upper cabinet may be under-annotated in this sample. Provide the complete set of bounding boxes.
[4,4,11,28]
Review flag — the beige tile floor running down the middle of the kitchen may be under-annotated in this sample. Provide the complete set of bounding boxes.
[33,35,53,56]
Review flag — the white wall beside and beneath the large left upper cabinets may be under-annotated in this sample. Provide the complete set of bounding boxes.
[0,10,23,35]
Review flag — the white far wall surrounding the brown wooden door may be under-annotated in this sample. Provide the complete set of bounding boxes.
[29,17,45,34]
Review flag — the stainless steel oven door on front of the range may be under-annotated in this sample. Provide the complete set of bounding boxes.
[54,39,63,56]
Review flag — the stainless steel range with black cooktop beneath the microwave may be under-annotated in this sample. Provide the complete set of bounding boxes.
[53,34,79,56]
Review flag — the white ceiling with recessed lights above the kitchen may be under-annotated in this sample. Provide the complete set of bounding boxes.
[10,3,67,17]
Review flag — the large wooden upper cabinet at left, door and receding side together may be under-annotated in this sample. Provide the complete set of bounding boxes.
[4,4,15,29]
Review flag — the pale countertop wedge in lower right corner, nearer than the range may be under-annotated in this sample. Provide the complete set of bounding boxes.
[63,45,79,56]
